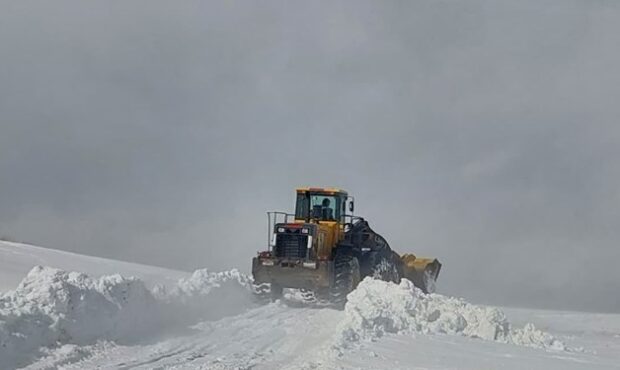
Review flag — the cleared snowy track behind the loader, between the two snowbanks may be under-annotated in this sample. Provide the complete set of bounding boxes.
[48,304,342,369]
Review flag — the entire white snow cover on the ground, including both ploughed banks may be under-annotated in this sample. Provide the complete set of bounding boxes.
[0,240,620,370]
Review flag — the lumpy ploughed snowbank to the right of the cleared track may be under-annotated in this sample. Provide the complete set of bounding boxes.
[339,278,566,350]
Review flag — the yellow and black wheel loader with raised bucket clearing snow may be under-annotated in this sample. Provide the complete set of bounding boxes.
[252,187,441,305]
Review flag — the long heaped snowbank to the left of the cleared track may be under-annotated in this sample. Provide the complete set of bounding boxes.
[0,266,251,369]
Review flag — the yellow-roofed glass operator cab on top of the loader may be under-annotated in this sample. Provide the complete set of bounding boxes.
[295,188,352,223]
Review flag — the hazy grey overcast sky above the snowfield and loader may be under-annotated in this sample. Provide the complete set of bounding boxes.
[0,0,620,312]
